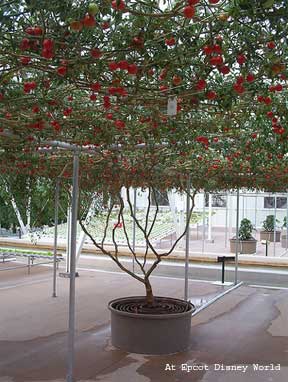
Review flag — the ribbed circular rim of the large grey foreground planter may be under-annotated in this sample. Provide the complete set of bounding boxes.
[108,296,196,320]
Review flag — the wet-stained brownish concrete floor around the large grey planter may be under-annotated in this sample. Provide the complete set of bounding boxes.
[0,265,288,382]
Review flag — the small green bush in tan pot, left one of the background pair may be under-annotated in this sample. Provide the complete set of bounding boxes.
[230,218,257,254]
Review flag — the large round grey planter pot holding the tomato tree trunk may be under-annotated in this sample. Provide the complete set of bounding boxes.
[108,296,195,355]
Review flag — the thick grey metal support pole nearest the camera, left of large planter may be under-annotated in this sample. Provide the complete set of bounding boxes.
[66,152,79,382]
